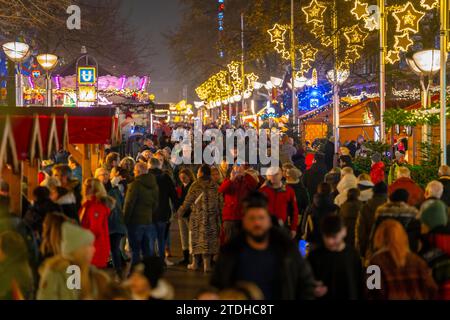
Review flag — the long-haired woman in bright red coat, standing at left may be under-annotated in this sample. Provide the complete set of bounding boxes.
[79,178,115,269]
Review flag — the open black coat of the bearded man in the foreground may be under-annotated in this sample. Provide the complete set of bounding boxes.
[211,228,315,300]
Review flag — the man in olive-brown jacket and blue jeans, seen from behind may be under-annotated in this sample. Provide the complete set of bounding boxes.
[123,163,159,265]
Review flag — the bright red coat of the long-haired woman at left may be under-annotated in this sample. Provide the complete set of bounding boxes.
[79,200,111,269]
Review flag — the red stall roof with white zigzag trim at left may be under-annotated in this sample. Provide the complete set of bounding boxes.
[0,107,118,169]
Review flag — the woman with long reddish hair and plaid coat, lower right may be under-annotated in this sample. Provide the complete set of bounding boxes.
[368,219,437,300]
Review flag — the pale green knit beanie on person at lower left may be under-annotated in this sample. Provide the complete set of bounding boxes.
[61,222,95,257]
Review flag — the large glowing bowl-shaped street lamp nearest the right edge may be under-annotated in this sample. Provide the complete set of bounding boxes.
[406,49,447,143]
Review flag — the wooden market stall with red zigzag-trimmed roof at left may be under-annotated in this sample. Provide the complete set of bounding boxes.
[0,107,119,214]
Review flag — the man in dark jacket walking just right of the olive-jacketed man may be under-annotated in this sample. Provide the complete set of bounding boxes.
[149,158,178,258]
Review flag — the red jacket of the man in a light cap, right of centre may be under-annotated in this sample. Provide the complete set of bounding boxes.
[260,183,298,231]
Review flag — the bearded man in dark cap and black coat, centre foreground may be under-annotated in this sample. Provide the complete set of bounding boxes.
[211,193,315,300]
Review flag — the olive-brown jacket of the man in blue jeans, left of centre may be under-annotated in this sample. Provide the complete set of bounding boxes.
[123,173,159,226]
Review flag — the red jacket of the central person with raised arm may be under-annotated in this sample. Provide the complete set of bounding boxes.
[219,174,258,221]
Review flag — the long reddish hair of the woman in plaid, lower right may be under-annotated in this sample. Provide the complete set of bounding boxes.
[374,219,410,268]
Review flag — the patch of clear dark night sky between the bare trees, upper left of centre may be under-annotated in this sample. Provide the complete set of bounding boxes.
[122,0,181,82]
